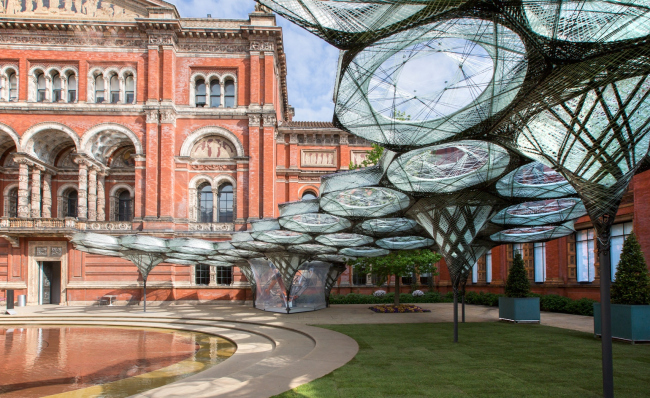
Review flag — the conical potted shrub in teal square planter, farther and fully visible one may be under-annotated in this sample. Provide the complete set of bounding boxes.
[499,252,540,323]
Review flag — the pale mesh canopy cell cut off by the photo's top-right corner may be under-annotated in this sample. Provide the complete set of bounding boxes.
[522,0,650,43]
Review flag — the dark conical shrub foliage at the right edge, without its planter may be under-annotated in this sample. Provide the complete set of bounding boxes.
[612,233,650,305]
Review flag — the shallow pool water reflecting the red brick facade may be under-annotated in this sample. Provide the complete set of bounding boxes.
[0,326,235,398]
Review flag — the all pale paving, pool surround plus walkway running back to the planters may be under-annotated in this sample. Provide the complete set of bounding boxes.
[0,303,593,398]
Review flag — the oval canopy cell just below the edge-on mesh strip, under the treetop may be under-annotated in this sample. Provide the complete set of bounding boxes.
[320,187,411,218]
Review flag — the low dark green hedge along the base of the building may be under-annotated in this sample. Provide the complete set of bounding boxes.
[330,292,596,316]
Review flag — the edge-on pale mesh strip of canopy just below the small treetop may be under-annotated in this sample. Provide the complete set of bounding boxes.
[320,149,396,195]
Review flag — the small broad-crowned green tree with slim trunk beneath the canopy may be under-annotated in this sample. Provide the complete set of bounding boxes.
[348,249,442,305]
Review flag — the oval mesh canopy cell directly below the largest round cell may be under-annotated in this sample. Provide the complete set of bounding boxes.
[388,140,510,193]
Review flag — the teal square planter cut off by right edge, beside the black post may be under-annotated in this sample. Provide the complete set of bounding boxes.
[594,303,650,343]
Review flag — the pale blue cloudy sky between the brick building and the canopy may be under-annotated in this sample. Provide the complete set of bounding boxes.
[167,0,338,121]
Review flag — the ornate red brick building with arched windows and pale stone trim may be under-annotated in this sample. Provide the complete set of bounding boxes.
[0,0,650,304]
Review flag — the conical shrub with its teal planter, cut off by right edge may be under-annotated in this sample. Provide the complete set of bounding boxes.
[594,234,650,343]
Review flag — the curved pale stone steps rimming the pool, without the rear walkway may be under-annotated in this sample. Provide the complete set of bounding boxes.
[0,306,359,398]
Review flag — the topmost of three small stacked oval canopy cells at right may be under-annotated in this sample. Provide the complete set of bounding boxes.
[496,162,576,199]
